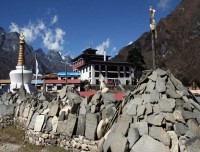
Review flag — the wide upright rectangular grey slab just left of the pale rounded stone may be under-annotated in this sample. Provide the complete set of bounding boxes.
[85,113,97,140]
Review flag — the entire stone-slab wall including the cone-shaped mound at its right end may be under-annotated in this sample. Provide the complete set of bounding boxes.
[0,69,200,152]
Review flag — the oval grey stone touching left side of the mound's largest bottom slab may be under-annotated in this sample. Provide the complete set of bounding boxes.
[128,127,140,148]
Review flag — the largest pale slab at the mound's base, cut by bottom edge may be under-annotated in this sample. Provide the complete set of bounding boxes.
[131,135,170,152]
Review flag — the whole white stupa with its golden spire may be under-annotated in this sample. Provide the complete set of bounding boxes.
[9,33,36,93]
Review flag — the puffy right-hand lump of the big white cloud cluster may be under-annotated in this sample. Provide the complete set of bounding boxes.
[42,28,65,51]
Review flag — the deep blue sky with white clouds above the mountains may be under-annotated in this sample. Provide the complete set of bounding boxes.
[0,0,181,57]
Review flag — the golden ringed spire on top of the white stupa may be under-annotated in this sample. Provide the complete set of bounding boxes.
[17,33,25,66]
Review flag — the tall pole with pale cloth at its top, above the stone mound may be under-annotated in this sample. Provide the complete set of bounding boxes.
[149,6,157,70]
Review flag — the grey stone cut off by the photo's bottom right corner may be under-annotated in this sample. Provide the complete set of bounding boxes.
[185,137,200,152]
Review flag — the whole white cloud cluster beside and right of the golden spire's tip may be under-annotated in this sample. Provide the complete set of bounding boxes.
[9,15,65,51]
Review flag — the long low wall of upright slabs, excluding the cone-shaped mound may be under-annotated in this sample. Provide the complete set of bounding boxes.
[0,86,116,151]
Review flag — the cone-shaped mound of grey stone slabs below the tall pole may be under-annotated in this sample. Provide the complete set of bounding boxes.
[102,69,200,152]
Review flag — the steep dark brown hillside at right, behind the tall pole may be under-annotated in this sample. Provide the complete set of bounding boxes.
[114,0,200,82]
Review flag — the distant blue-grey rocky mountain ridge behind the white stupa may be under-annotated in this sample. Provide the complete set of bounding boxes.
[0,27,72,79]
